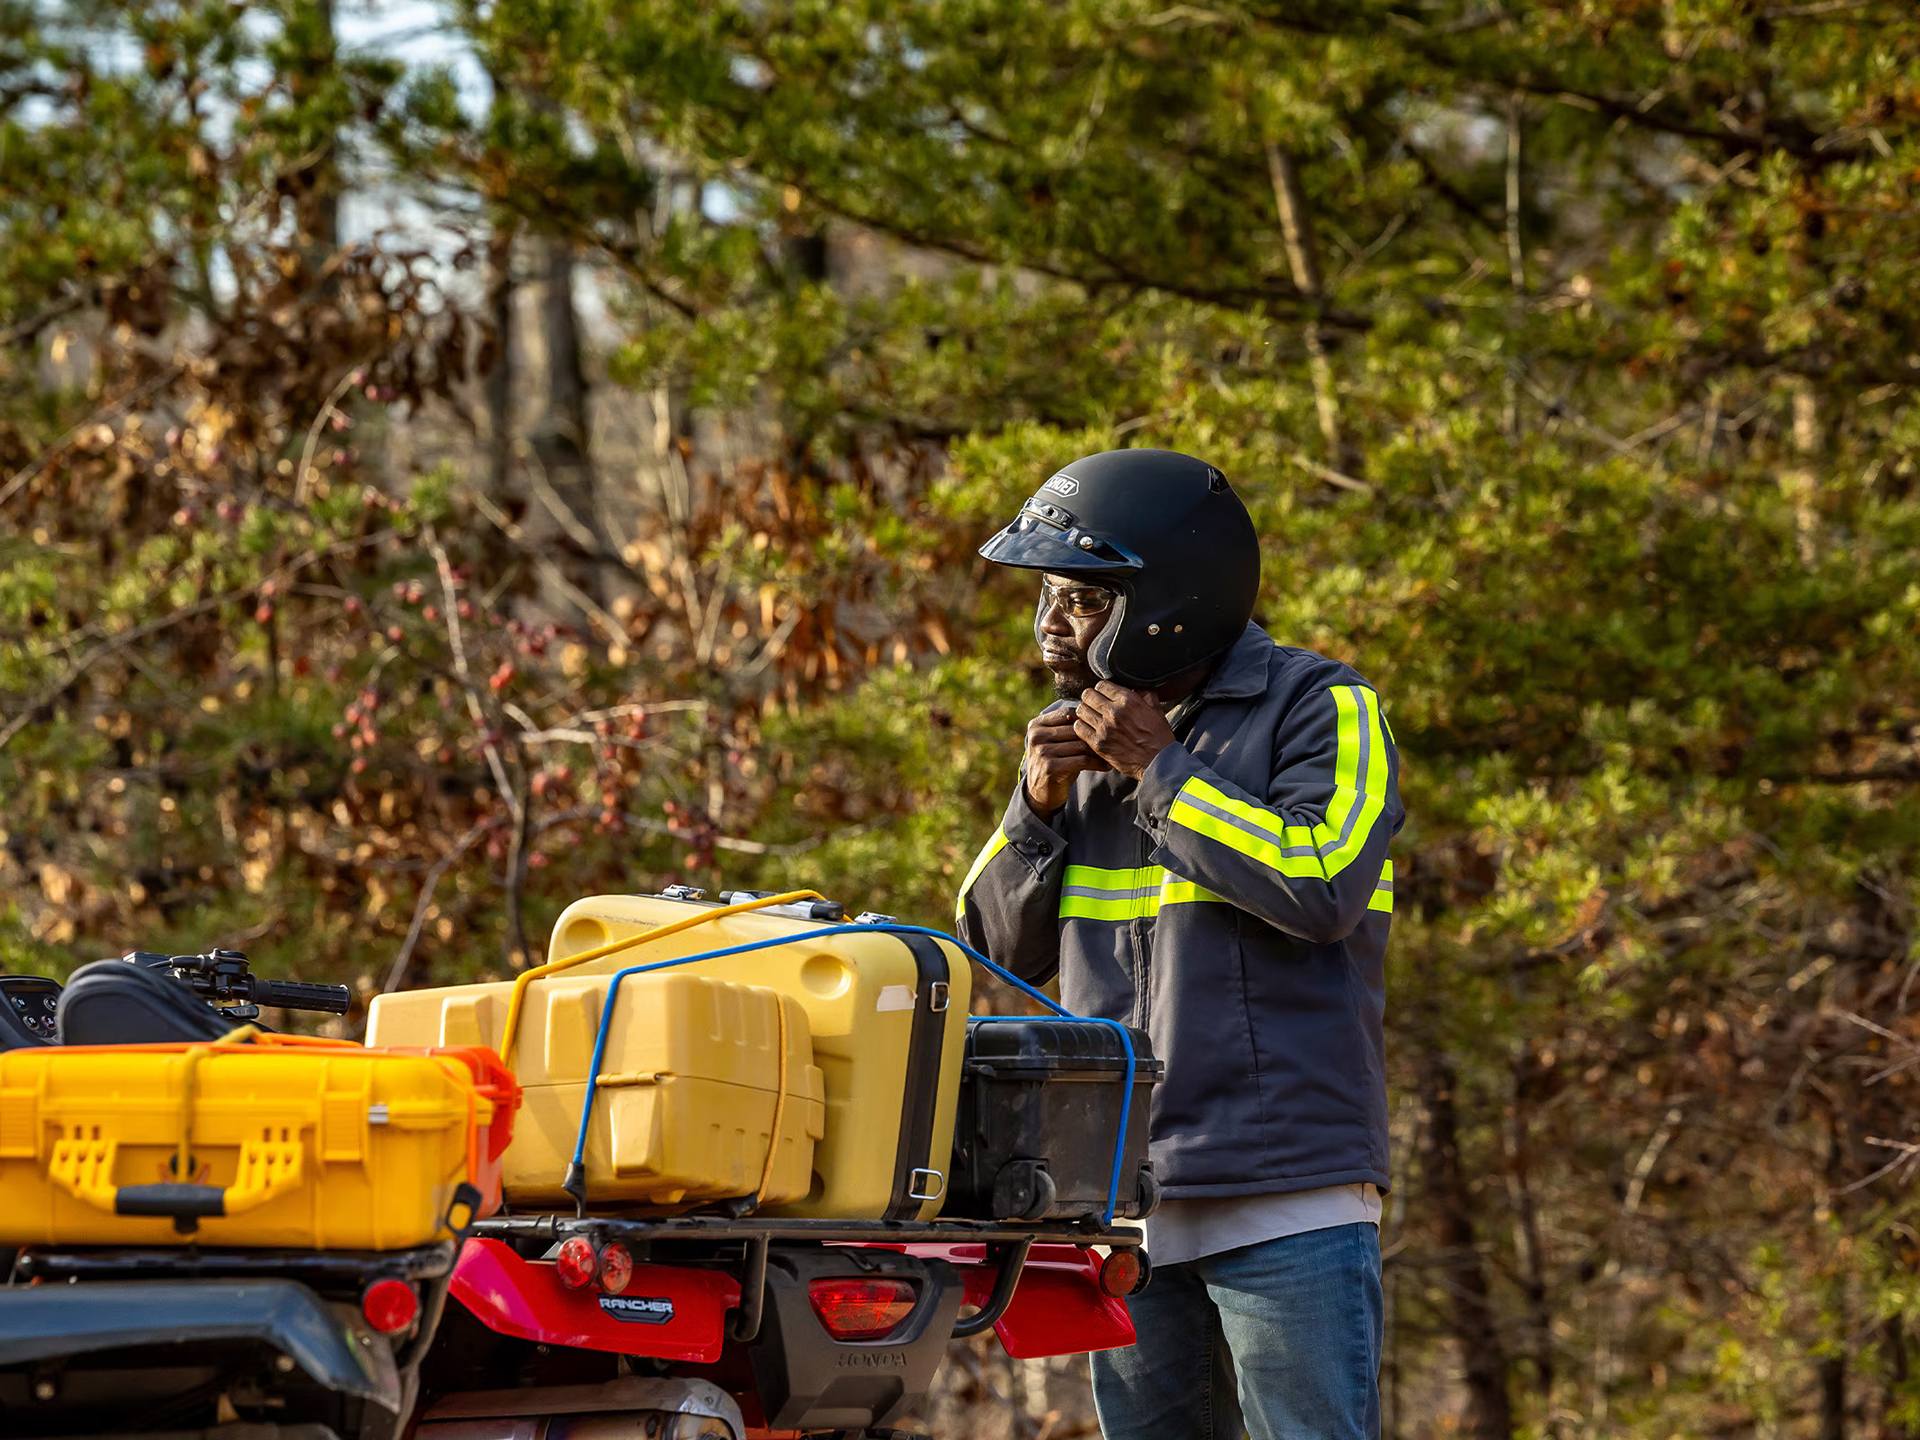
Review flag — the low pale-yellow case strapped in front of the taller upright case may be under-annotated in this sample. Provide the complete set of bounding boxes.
[367,972,826,1206]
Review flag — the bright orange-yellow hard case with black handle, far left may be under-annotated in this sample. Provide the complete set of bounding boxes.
[0,1043,513,1250]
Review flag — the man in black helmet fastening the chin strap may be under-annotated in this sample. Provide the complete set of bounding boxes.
[958,449,1404,1440]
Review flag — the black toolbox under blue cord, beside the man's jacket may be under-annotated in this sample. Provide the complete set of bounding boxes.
[941,1018,1165,1221]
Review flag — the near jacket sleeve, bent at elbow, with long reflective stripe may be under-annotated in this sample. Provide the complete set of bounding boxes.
[1135,684,1404,945]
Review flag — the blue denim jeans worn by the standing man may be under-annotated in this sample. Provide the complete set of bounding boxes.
[1092,1223,1380,1440]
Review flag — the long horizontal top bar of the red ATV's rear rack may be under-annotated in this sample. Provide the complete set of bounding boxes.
[468,1215,1146,1250]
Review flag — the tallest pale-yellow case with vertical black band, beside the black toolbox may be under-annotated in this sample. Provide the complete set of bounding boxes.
[536,895,972,1219]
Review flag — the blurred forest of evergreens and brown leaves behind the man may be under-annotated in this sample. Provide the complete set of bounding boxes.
[0,0,1920,1440]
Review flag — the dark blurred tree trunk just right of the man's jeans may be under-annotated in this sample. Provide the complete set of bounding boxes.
[1421,1054,1513,1440]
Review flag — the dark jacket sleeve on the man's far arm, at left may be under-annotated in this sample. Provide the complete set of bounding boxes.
[954,781,1068,985]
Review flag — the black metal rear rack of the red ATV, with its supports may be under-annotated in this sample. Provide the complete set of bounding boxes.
[467,1213,1150,1342]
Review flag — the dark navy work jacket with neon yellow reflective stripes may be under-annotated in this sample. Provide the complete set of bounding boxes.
[958,624,1405,1198]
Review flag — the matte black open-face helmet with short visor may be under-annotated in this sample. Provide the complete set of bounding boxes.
[979,449,1260,689]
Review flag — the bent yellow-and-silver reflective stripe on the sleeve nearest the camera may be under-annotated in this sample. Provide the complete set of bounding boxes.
[1167,685,1386,879]
